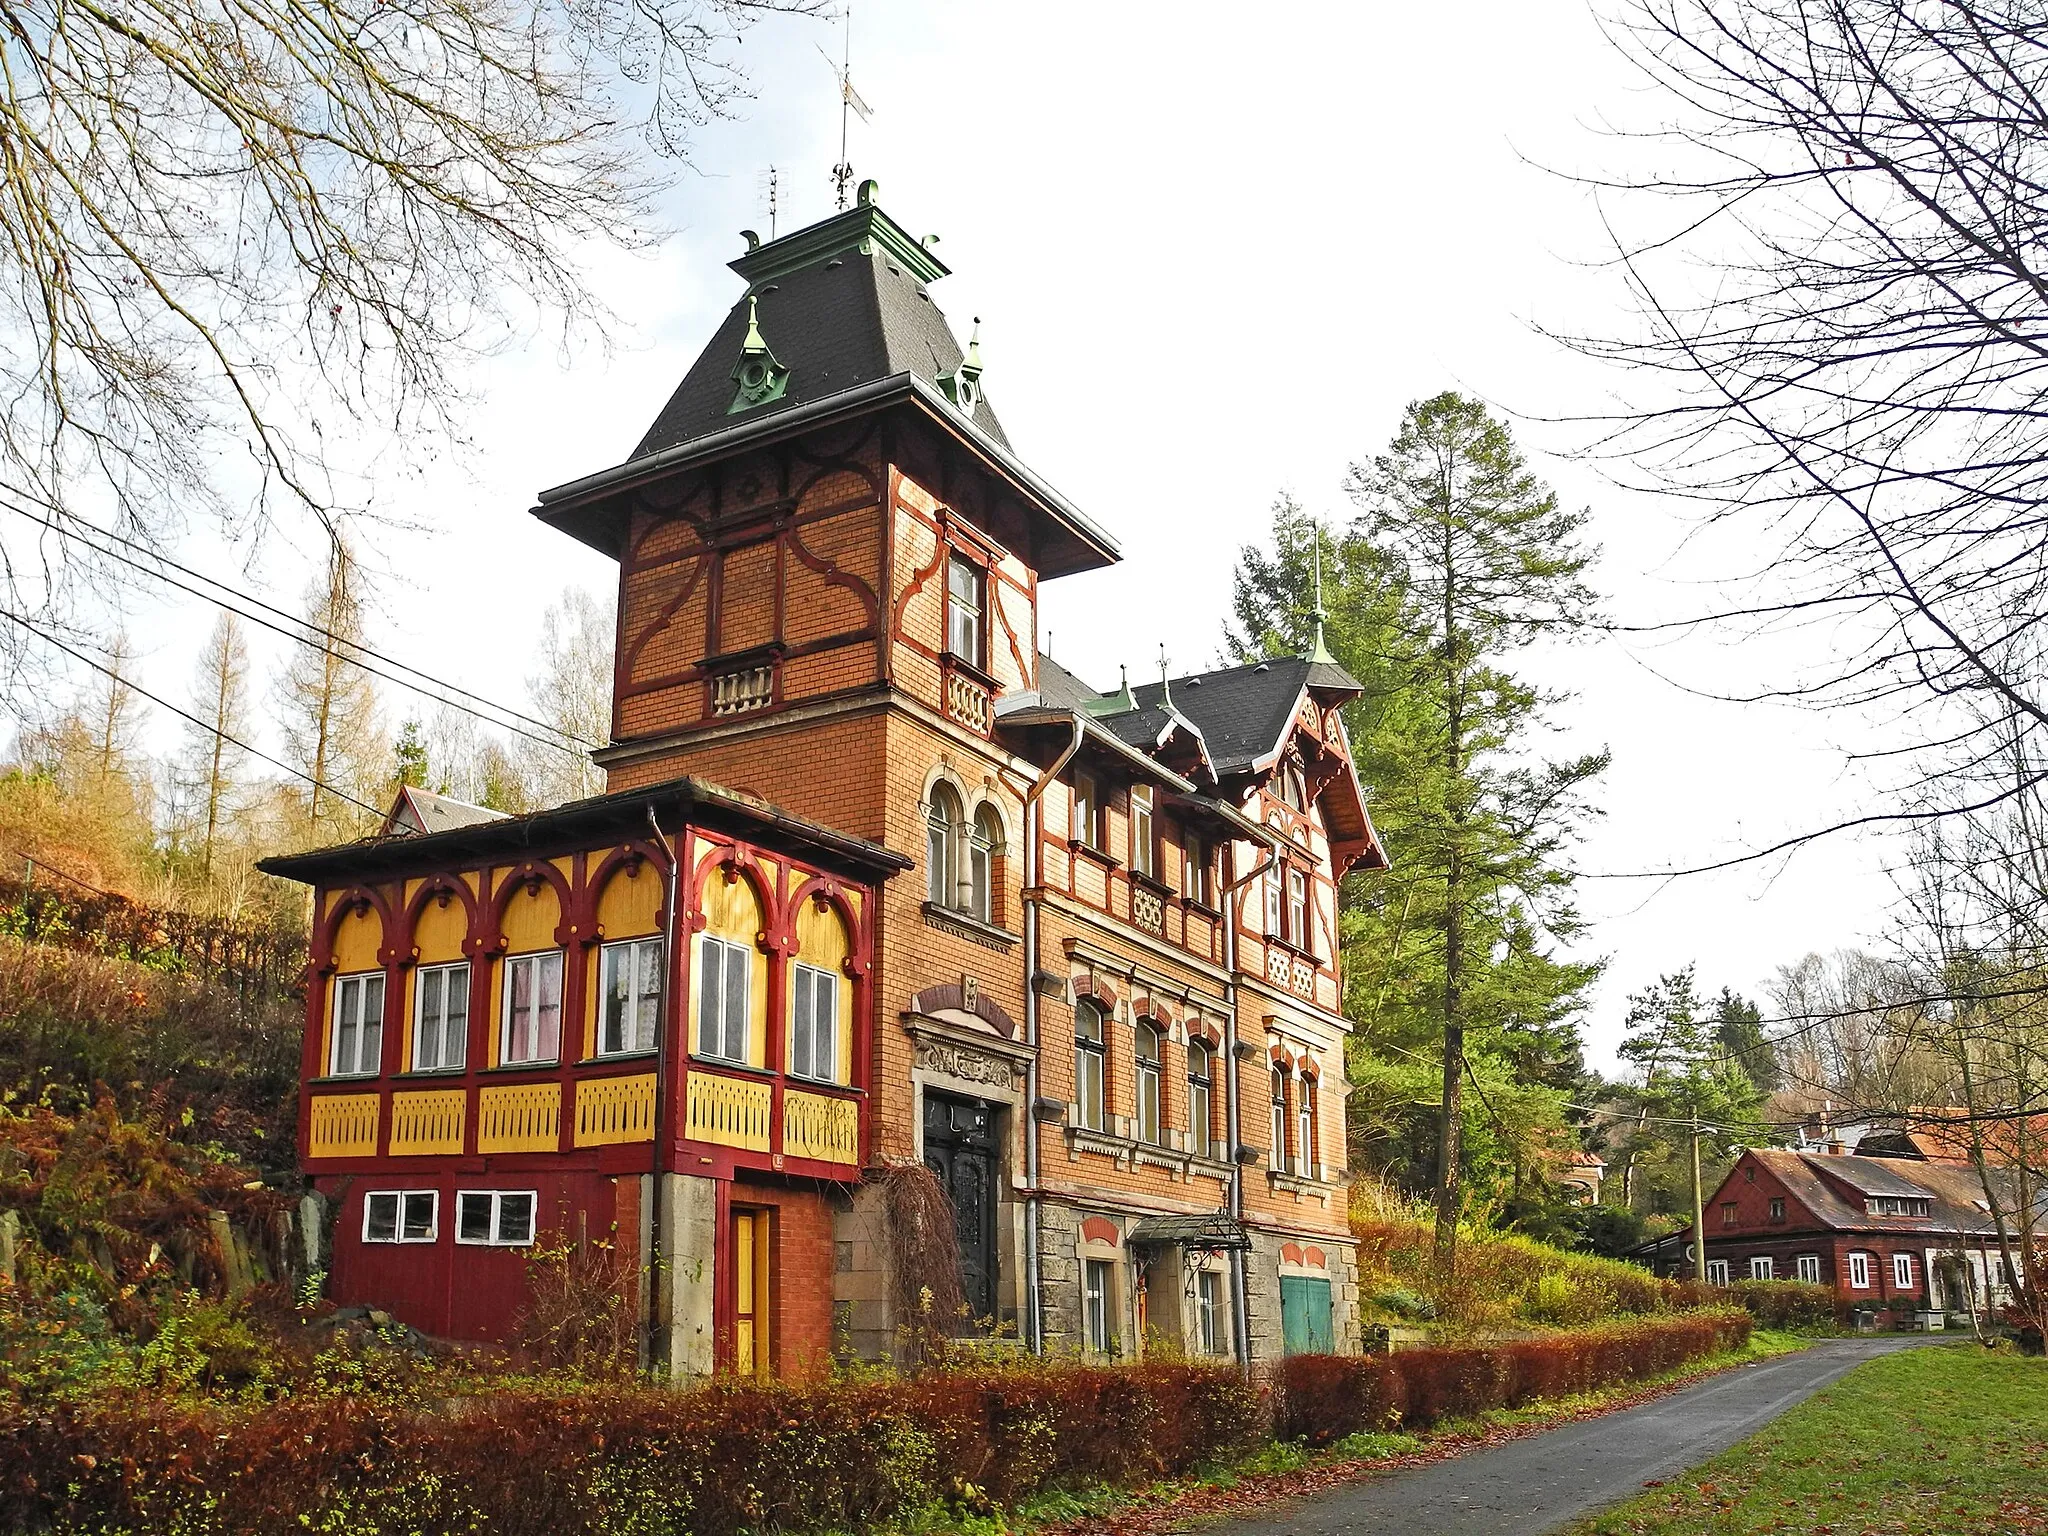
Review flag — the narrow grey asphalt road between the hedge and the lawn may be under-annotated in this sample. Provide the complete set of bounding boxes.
[1202,1337,1935,1536]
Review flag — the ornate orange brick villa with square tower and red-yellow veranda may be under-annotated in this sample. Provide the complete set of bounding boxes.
[251,182,1386,1374]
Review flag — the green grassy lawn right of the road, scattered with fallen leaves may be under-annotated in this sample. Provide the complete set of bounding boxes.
[1573,1343,2048,1536]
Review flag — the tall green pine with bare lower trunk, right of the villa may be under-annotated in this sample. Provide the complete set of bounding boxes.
[1348,393,1608,1266]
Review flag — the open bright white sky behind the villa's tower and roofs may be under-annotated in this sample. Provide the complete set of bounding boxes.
[8,0,1890,1065]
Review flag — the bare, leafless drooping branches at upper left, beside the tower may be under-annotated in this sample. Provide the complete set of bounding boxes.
[0,0,819,626]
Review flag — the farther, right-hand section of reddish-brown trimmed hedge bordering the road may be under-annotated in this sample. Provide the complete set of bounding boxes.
[1278,1311,1751,1446]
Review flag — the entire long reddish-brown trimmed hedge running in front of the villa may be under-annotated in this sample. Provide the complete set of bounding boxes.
[0,1313,1749,1536]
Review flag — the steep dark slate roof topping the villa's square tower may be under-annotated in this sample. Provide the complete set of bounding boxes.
[631,207,1010,459]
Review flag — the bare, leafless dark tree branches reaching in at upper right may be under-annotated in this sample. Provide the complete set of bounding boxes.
[1569,0,2048,868]
